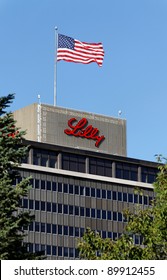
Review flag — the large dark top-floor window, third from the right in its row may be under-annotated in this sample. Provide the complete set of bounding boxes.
[89,158,112,177]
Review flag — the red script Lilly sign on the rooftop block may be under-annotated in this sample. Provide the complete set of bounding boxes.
[64,118,105,147]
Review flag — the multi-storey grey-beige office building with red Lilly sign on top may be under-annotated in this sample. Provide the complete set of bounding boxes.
[14,104,157,259]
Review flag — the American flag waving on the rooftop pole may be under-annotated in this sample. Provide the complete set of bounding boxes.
[57,34,104,66]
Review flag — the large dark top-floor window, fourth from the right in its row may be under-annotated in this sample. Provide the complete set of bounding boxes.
[62,153,86,173]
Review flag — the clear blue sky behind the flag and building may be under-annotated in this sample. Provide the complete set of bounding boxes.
[0,0,167,161]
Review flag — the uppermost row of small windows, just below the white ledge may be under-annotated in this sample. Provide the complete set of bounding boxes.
[18,179,153,205]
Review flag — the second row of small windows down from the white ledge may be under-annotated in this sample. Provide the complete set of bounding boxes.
[22,198,125,222]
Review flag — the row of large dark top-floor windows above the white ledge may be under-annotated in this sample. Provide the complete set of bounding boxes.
[24,148,158,183]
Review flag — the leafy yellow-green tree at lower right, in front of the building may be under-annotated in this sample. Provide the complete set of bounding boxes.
[78,164,167,260]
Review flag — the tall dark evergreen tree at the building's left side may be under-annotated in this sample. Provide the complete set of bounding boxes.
[0,94,41,260]
